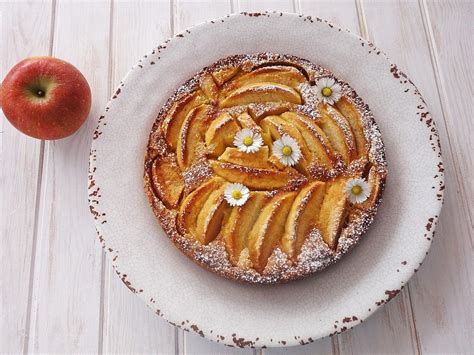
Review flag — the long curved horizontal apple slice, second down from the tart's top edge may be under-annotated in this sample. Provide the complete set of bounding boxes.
[219,83,301,107]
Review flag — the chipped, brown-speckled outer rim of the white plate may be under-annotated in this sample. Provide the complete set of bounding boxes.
[88,11,445,348]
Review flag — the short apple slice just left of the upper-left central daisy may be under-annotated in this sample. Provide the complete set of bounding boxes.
[205,112,240,157]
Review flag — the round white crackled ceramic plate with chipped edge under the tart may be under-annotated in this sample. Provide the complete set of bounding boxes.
[89,13,444,347]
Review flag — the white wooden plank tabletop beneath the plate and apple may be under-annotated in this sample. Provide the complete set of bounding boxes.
[0,0,474,354]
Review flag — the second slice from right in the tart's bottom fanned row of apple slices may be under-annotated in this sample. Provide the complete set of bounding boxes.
[281,181,326,259]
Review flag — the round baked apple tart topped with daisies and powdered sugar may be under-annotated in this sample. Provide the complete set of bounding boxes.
[144,53,387,283]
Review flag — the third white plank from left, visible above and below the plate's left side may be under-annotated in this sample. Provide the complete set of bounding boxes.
[102,1,175,354]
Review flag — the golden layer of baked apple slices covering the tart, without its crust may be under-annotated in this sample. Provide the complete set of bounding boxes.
[146,57,385,273]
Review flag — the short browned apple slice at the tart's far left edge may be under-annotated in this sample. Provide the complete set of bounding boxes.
[151,155,184,208]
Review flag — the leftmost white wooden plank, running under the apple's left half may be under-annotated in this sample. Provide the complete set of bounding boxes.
[0,1,52,353]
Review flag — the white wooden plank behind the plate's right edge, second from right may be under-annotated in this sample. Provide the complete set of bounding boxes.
[363,1,473,353]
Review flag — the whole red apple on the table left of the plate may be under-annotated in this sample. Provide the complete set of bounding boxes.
[0,57,91,140]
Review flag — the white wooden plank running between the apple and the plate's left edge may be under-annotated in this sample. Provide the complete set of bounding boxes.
[28,1,110,353]
